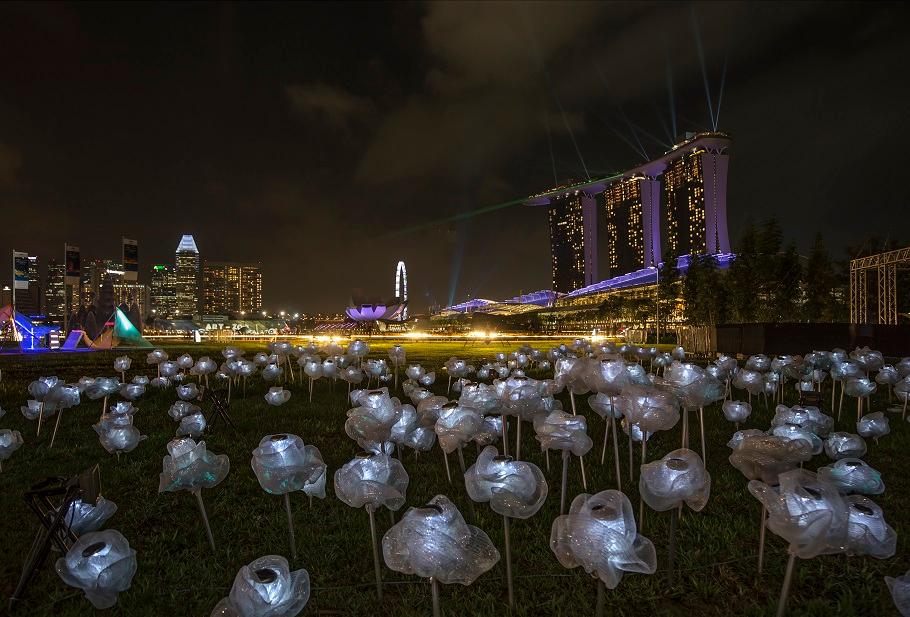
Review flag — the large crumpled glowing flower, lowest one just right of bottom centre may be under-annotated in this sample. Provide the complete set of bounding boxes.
[550,491,657,589]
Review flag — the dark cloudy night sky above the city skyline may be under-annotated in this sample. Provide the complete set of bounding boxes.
[0,2,910,312]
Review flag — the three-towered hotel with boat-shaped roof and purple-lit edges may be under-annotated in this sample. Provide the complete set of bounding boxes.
[525,133,732,294]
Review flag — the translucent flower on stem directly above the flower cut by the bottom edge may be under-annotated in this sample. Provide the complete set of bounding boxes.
[250,434,326,499]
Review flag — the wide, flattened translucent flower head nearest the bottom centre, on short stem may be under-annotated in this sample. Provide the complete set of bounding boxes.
[382,495,499,585]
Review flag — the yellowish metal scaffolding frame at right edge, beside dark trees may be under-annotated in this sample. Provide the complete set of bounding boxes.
[850,246,910,325]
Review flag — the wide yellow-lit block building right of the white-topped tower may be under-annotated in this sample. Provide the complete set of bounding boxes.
[202,261,262,316]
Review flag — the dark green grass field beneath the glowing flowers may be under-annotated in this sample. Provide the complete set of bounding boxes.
[0,343,910,617]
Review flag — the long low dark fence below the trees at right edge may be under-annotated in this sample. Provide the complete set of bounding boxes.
[715,323,910,357]
